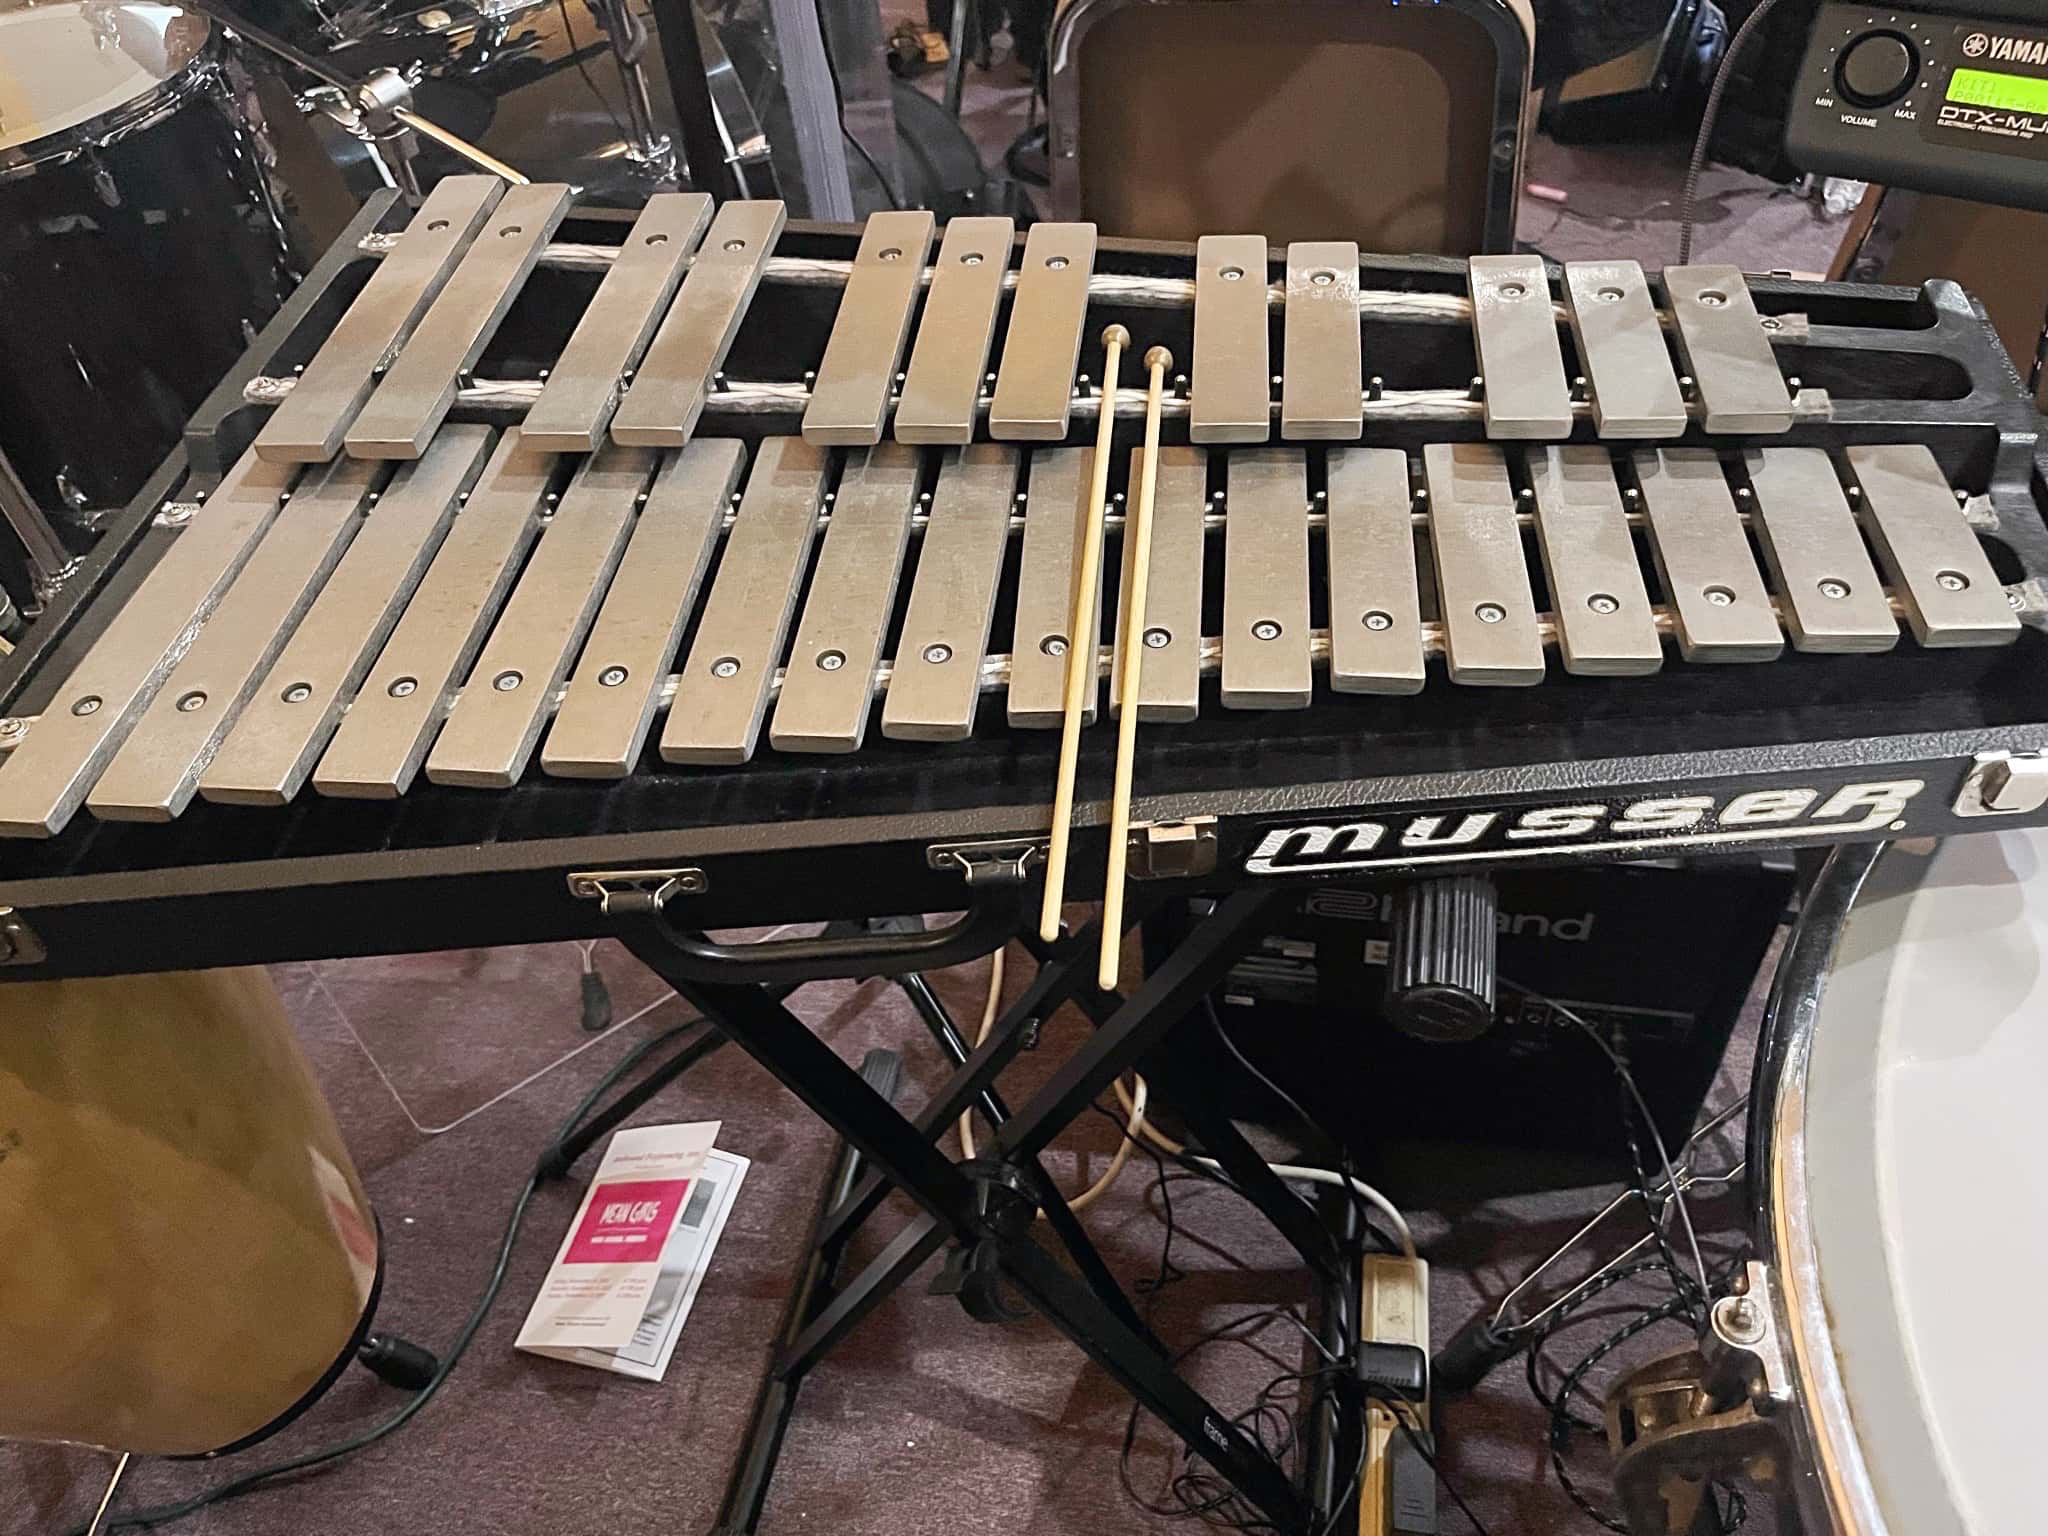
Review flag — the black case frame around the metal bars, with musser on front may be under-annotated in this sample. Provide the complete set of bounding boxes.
[0,199,2048,979]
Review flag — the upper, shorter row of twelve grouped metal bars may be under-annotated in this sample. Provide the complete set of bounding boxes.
[256,176,1796,463]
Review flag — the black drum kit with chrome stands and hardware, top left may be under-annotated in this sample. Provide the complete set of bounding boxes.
[0,0,776,637]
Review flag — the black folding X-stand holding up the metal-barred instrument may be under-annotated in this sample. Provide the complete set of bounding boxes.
[606,881,1358,1536]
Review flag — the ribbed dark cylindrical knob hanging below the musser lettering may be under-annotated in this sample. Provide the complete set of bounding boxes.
[1386,874,1499,1040]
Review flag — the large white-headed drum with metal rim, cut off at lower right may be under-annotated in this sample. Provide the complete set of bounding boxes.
[1751,831,2048,1536]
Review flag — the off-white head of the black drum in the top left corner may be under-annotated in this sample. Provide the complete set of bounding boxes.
[0,0,209,152]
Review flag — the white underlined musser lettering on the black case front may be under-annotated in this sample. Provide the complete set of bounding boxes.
[1245,778,1927,874]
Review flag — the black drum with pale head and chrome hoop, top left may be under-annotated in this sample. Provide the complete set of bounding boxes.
[0,0,299,528]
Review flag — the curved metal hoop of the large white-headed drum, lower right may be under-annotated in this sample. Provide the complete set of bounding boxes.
[1751,844,1888,1536]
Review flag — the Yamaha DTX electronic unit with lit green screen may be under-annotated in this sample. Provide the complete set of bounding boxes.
[1786,0,2048,209]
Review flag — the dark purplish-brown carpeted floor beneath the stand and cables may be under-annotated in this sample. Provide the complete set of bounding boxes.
[0,925,1761,1536]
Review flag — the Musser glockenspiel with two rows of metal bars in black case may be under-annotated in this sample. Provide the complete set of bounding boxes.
[0,176,2048,975]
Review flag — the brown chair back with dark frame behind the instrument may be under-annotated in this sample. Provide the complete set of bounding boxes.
[1049,0,1534,256]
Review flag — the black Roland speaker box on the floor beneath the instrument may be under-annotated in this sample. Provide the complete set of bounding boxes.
[1147,862,1792,1186]
